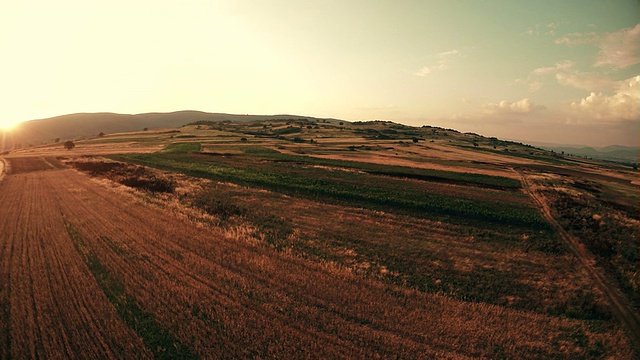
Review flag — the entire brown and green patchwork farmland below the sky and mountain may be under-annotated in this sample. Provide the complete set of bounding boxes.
[0,119,639,359]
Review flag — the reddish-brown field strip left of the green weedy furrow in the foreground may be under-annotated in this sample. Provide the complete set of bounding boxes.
[0,158,151,359]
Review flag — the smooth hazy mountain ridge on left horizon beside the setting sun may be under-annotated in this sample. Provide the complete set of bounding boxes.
[0,111,334,148]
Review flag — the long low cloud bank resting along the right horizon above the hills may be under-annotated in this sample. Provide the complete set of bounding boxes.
[432,92,640,146]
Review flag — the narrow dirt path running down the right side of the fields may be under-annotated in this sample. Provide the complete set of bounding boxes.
[520,172,640,354]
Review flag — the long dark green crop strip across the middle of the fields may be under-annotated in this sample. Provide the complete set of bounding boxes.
[112,153,549,230]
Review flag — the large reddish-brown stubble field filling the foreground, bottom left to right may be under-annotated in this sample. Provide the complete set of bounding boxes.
[0,158,631,358]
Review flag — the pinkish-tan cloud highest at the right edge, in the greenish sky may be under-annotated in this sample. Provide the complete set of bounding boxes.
[554,24,640,69]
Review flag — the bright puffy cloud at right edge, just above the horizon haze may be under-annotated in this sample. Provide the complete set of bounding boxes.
[570,75,640,122]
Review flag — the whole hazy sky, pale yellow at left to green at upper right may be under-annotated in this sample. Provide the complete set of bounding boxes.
[0,0,640,145]
